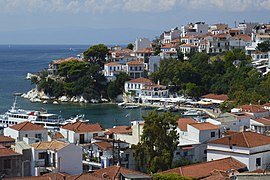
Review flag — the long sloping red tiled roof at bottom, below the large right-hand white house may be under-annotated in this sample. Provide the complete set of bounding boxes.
[160,157,246,178]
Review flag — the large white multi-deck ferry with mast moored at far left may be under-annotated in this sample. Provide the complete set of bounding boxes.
[0,96,65,129]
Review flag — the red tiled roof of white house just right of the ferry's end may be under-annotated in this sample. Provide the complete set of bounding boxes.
[62,121,104,133]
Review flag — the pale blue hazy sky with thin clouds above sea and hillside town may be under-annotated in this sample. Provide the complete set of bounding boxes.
[0,0,270,45]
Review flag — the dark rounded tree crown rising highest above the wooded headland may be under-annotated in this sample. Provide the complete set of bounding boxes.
[83,44,109,67]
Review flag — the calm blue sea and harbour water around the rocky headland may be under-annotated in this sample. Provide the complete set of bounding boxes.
[0,45,150,127]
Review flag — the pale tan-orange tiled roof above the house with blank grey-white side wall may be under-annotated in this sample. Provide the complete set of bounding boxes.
[31,140,69,150]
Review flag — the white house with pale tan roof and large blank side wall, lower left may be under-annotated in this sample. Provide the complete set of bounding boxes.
[31,141,82,176]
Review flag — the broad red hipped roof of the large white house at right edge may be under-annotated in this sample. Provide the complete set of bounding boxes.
[209,131,270,148]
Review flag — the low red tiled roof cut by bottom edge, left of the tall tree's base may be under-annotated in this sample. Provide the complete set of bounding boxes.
[92,166,151,179]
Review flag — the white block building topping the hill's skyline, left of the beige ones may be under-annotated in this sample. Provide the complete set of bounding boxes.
[181,22,208,37]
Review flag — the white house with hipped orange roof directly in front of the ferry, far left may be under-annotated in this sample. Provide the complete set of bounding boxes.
[4,121,48,144]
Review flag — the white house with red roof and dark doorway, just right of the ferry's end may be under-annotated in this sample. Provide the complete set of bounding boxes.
[60,121,105,144]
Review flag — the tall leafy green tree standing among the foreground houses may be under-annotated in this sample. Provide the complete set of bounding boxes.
[134,111,178,173]
